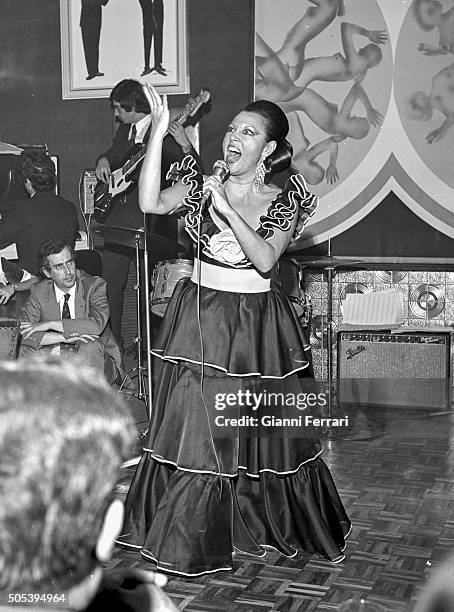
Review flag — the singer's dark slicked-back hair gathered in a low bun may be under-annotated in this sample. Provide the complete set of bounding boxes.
[244,100,293,177]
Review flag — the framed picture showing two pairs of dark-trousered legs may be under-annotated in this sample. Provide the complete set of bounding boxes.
[60,0,189,100]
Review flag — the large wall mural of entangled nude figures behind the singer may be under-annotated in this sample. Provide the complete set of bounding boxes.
[255,0,454,246]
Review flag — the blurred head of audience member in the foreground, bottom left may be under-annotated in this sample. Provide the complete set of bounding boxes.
[0,359,134,609]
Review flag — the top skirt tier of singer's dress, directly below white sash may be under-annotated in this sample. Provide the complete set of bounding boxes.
[153,278,312,378]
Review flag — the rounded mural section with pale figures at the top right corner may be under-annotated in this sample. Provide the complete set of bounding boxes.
[394,0,454,187]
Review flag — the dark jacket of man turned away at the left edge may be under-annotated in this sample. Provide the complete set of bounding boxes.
[0,192,79,274]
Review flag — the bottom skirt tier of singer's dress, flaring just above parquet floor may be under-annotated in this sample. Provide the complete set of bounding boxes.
[118,454,350,576]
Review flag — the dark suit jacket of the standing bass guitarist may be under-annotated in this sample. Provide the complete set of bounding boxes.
[100,123,203,233]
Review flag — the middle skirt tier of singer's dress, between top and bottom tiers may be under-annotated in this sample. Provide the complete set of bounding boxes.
[140,361,321,478]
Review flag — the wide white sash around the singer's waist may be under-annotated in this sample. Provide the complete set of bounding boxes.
[191,259,271,293]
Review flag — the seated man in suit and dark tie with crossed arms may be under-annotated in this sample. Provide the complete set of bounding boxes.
[20,240,121,383]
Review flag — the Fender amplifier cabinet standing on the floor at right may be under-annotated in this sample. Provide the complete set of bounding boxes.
[337,330,451,410]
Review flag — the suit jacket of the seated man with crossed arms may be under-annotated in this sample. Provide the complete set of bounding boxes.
[20,270,121,372]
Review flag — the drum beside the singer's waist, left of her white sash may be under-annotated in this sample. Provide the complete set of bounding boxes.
[150,259,194,317]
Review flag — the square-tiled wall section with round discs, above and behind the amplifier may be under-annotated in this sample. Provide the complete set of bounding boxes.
[302,270,454,378]
